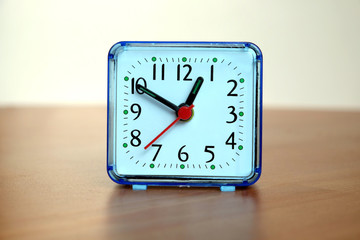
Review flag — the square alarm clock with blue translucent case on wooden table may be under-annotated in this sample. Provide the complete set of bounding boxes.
[107,42,263,191]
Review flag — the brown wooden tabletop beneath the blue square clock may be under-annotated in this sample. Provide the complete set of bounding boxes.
[0,107,360,240]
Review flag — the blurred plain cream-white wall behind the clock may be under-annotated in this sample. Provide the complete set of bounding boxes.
[0,0,360,110]
